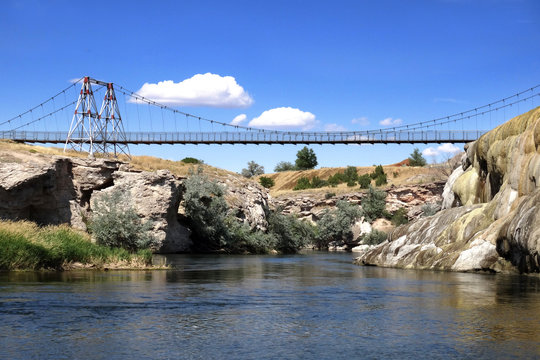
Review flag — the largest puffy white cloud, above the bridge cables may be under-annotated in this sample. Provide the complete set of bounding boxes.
[135,73,253,108]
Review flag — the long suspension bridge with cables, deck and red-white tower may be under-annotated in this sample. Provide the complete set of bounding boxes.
[0,77,540,156]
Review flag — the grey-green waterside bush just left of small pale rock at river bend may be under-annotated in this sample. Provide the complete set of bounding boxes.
[316,200,363,249]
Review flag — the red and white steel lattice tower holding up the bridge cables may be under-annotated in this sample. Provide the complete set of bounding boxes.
[64,76,130,158]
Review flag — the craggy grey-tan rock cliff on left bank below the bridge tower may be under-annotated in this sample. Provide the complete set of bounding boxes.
[0,151,270,253]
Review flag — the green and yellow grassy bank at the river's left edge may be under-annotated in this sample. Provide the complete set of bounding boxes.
[0,221,152,270]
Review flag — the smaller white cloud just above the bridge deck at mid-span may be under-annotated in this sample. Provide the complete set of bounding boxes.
[249,107,317,130]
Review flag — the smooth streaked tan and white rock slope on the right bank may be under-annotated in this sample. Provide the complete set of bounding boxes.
[355,108,540,272]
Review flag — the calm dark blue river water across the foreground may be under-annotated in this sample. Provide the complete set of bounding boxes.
[0,252,540,359]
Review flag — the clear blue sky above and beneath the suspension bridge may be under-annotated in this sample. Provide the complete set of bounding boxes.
[0,0,540,172]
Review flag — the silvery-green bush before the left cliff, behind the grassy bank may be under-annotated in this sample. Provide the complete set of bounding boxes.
[88,190,155,251]
